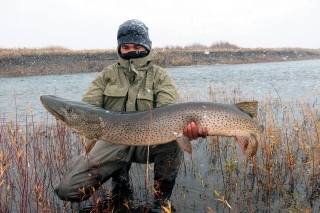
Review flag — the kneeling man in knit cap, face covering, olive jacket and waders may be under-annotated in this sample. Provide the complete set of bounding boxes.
[55,20,204,212]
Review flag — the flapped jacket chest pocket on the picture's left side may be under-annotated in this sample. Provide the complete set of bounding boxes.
[103,84,128,111]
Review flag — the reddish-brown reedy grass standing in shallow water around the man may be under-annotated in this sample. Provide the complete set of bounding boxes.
[0,88,320,212]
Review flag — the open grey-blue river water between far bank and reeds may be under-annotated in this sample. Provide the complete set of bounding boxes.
[0,60,320,121]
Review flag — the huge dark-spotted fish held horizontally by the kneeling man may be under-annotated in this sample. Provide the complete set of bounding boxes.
[40,95,263,156]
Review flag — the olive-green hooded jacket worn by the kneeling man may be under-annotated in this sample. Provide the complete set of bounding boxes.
[82,51,179,111]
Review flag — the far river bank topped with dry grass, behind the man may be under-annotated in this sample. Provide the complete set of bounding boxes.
[0,46,320,77]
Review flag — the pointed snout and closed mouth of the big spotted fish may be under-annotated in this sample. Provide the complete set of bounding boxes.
[40,95,65,121]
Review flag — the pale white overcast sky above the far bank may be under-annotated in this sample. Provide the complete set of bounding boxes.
[0,0,320,49]
